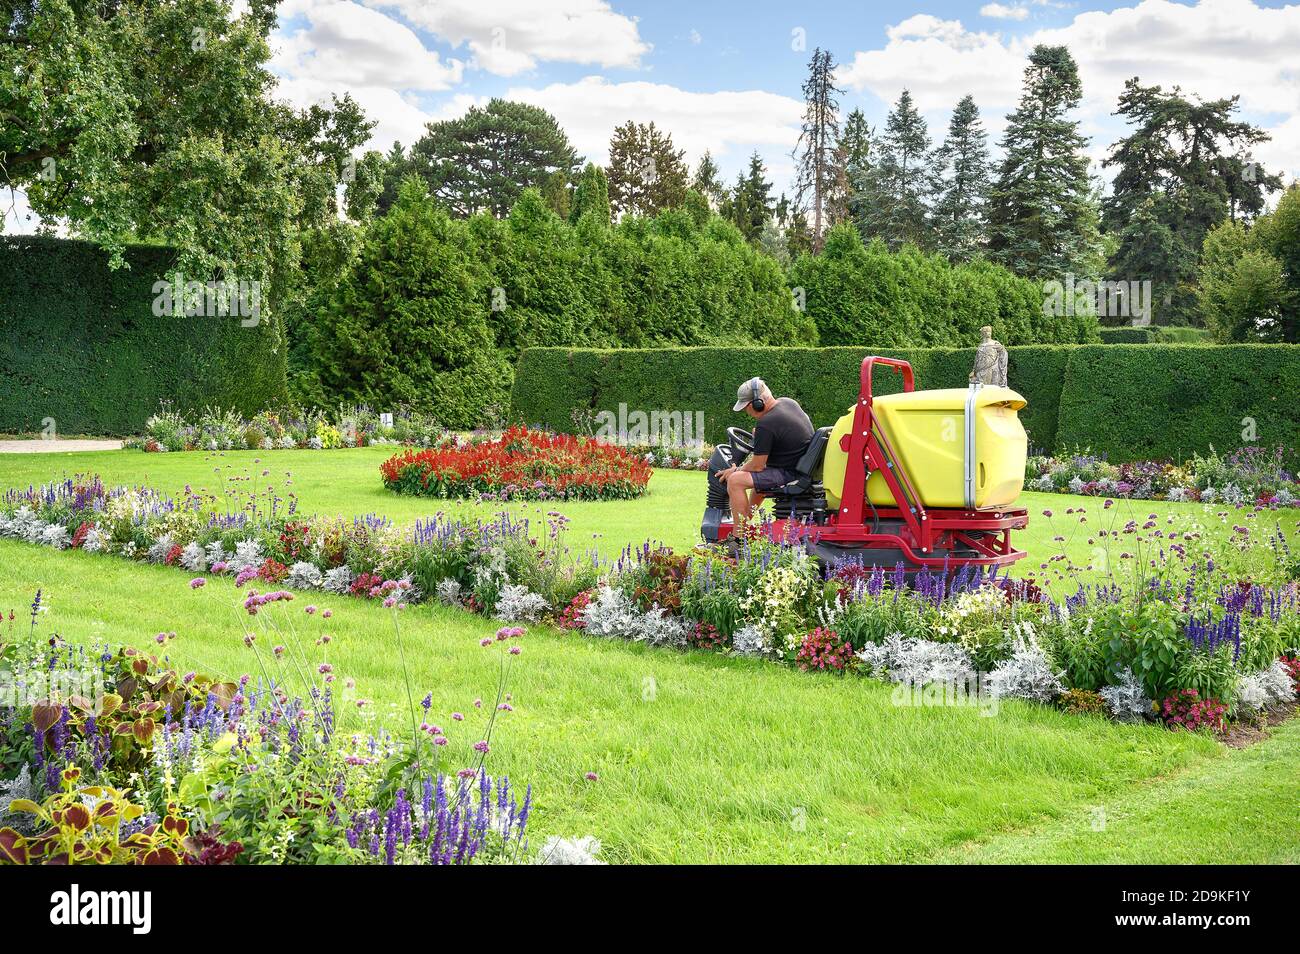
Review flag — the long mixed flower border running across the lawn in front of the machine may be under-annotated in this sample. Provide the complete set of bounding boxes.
[0,478,1300,729]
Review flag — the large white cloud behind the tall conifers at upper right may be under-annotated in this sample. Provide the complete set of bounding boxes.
[839,0,1300,174]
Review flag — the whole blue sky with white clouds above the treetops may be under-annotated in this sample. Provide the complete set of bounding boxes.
[266,0,1300,197]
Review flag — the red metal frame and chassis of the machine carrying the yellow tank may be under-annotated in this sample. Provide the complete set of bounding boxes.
[719,355,1030,569]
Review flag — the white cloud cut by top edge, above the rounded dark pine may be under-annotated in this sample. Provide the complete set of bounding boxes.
[367,0,650,77]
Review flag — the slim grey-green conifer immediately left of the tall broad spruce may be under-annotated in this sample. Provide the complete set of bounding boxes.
[935,95,991,261]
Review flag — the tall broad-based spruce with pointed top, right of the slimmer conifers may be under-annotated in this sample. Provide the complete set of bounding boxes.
[988,44,1097,278]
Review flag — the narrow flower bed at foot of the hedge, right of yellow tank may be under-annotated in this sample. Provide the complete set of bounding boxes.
[1024,445,1300,507]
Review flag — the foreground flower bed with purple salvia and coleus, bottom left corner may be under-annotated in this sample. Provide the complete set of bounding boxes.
[0,591,548,864]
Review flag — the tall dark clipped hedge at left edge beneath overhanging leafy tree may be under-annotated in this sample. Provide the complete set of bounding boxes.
[0,235,285,434]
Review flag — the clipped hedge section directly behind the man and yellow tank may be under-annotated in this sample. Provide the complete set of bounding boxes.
[511,344,1067,447]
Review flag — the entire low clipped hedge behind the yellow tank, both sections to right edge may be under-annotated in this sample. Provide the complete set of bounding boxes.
[511,344,1300,463]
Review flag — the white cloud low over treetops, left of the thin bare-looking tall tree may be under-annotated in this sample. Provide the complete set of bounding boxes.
[506,77,803,174]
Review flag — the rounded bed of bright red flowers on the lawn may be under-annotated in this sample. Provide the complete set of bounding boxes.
[380,428,650,500]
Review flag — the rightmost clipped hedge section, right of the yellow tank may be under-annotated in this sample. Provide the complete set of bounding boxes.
[1057,344,1300,464]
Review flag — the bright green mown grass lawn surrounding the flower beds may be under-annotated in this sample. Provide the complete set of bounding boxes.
[0,448,1300,862]
